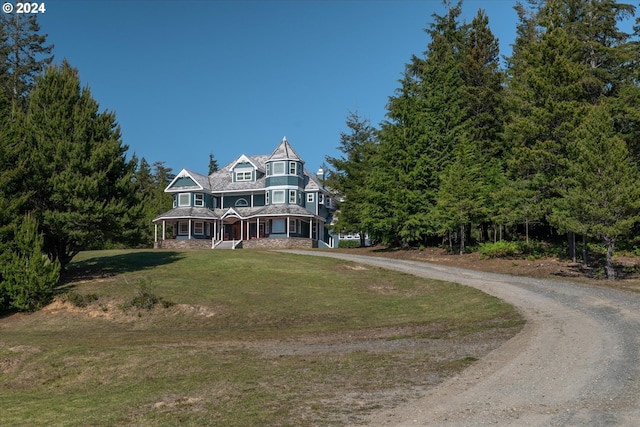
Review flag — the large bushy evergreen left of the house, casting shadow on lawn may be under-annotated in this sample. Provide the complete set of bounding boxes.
[14,62,137,267]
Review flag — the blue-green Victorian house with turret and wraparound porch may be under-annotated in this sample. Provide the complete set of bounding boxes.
[153,138,334,249]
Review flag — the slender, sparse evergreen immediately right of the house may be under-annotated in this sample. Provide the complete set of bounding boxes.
[326,112,376,246]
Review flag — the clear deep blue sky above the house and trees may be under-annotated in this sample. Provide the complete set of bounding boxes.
[33,0,516,173]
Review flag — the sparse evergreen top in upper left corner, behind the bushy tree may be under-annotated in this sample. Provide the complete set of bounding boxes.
[0,13,53,107]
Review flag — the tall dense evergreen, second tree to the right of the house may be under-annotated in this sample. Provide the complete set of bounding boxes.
[364,3,465,246]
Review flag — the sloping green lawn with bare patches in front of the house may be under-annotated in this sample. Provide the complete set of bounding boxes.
[0,250,522,426]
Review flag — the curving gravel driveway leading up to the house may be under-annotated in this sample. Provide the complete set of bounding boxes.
[287,251,640,426]
